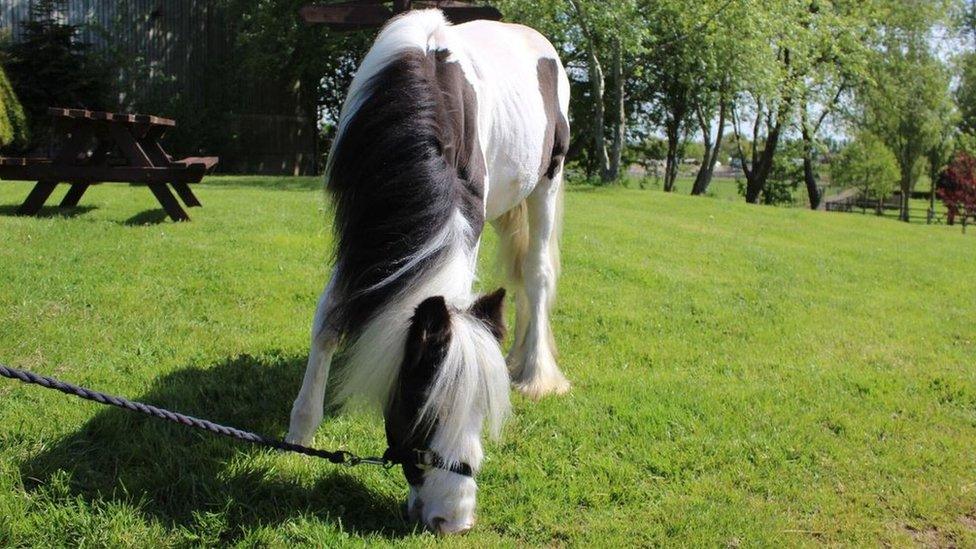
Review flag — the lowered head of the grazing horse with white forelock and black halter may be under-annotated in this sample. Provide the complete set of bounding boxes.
[384,289,509,534]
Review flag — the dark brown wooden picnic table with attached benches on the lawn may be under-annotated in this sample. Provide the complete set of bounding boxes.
[0,108,217,221]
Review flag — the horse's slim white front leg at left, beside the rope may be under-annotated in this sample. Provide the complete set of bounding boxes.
[286,277,339,445]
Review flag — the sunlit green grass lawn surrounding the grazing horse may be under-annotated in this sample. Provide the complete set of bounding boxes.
[0,178,976,547]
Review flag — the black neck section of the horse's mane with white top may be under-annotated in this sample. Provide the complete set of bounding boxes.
[327,11,484,334]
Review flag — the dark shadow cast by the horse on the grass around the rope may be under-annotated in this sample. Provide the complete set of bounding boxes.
[21,355,414,543]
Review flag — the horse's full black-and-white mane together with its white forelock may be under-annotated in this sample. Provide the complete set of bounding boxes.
[327,10,500,425]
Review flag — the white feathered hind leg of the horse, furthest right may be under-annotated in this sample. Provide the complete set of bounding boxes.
[509,170,569,399]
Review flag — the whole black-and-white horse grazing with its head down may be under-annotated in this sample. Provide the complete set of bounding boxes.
[288,10,569,533]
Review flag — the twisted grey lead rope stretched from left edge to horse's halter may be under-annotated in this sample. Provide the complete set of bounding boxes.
[0,364,392,469]
